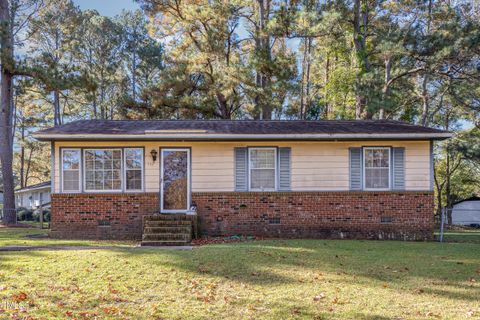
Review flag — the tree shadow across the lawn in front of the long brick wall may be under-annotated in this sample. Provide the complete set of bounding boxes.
[121,240,480,300]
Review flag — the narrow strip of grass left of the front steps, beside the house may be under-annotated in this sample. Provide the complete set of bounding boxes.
[0,228,136,247]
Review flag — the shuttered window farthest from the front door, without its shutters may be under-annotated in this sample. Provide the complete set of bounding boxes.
[363,147,390,190]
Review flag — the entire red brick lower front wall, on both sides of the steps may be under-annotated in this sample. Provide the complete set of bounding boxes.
[51,192,433,240]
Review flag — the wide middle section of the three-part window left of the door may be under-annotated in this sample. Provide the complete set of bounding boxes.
[84,149,122,191]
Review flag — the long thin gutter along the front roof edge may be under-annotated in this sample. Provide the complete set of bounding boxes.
[32,132,453,141]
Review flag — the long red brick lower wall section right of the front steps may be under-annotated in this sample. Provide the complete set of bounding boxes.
[192,192,433,240]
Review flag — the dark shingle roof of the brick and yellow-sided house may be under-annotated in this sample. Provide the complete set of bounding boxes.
[35,120,446,140]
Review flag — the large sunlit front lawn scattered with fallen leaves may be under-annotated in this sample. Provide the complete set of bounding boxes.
[0,230,480,320]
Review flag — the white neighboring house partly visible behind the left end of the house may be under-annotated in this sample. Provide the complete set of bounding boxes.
[15,181,52,210]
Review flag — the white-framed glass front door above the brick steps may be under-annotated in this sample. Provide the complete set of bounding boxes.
[160,148,190,213]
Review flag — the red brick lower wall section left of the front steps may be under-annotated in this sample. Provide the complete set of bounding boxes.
[50,193,159,240]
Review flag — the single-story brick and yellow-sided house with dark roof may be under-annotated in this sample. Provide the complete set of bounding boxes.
[34,120,451,244]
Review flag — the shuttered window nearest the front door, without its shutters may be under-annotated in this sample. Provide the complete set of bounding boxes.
[249,148,277,191]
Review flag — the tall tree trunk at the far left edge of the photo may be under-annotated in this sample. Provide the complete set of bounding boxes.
[0,0,17,224]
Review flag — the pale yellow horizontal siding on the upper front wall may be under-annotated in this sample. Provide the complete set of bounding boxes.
[54,141,430,192]
